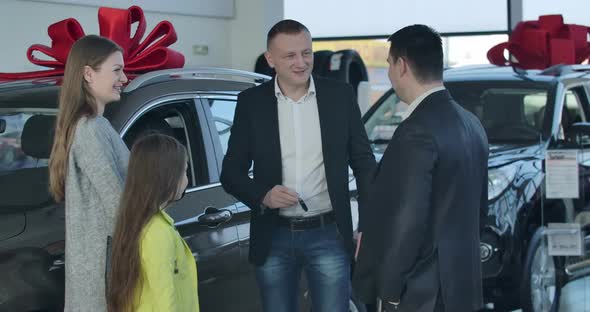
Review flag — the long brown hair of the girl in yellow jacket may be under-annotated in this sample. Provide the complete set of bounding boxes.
[107,134,187,312]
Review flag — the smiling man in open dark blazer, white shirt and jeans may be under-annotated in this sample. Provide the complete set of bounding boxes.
[221,20,376,312]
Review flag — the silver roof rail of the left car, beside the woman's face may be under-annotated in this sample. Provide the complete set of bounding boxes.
[123,67,271,92]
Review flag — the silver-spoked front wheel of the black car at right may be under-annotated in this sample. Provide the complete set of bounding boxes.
[521,227,564,312]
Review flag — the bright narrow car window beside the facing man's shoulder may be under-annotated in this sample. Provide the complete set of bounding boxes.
[207,97,237,155]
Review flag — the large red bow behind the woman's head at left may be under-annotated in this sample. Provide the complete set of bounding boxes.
[0,6,184,80]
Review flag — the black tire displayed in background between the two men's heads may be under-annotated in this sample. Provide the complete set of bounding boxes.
[325,49,369,94]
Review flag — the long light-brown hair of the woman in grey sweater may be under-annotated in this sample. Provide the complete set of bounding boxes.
[49,35,123,202]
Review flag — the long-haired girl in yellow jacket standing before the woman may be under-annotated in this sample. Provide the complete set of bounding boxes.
[107,134,199,312]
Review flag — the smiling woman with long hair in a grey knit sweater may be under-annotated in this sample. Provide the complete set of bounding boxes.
[49,35,129,312]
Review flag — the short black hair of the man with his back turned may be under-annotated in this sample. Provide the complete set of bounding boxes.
[387,25,443,82]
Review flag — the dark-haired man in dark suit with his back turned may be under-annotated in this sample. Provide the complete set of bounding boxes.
[353,25,488,312]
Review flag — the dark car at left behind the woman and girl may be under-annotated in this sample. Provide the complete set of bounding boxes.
[0,68,364,312]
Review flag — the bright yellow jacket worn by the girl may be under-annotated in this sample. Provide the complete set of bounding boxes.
[135,210,199,312]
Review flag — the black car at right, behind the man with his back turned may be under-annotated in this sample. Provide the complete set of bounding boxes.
[363,65,590,311]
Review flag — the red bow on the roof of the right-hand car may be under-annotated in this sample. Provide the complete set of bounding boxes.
[487,15,590,69]
